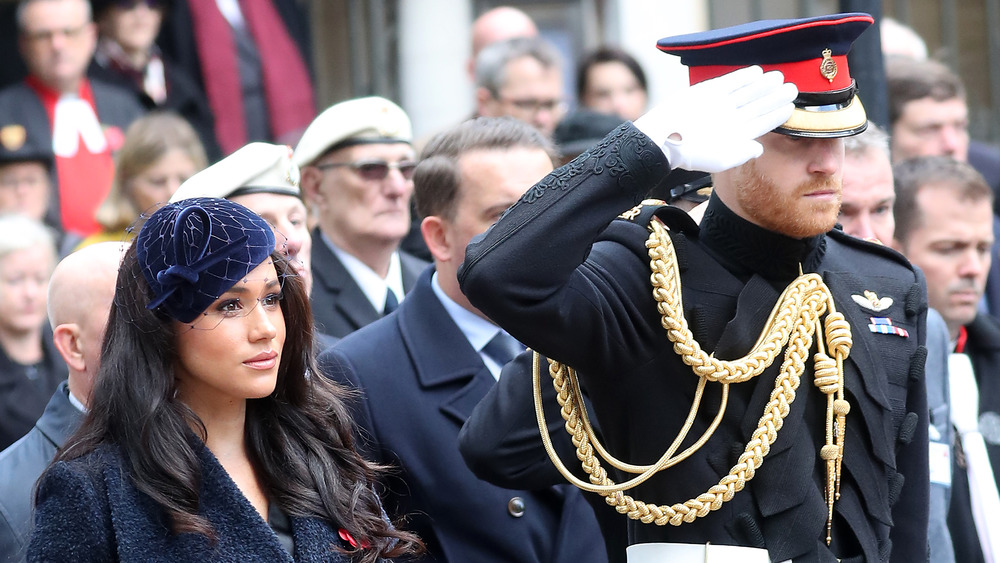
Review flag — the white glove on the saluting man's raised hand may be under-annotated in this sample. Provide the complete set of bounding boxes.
[635,66,798,172]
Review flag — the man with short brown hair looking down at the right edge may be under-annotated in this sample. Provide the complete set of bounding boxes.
[894,156,1000,563]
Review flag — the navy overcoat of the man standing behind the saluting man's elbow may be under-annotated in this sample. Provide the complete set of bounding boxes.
[320,268,605,563]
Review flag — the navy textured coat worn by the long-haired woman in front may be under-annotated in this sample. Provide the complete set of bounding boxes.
[28,437,368,563]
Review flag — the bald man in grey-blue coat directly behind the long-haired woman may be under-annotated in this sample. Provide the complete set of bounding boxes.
[0,242,127,562]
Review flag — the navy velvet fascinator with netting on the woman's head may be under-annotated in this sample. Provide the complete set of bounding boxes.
[135,197,274,323]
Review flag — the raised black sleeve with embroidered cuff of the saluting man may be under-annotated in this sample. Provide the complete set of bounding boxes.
[459,123,670,369]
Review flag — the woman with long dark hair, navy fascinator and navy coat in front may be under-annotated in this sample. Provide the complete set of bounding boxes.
[28,198,419,562]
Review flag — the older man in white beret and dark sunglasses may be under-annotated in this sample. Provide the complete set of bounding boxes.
[292,97,427,338]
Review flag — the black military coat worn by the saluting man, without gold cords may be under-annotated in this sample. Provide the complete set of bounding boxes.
[459,123,928,562]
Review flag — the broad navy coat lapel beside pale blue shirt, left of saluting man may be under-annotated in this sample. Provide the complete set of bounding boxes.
[397,268,496,425]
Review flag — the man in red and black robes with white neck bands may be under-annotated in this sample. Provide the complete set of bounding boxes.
[0,0,143,236]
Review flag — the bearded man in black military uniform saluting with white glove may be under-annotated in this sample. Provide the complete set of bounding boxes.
[459,14,928,562]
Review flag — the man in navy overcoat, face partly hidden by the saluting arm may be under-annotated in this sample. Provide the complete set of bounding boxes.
[321,118,605,563]
